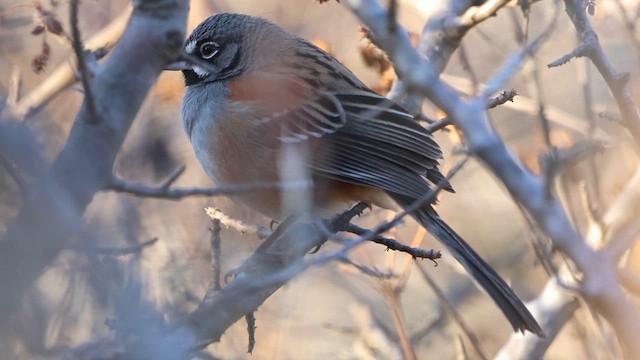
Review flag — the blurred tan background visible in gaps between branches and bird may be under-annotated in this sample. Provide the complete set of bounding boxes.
[0,0,640,360]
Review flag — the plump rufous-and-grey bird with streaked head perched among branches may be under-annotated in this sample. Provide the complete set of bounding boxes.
[173,13,544,337]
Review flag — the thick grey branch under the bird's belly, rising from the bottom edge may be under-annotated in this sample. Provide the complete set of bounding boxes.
[66,71,468,357]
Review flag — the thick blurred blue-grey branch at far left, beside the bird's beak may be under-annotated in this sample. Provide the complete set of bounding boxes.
[0,0,188,324]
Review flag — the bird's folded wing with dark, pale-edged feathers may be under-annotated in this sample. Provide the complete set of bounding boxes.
[256,90,452,197]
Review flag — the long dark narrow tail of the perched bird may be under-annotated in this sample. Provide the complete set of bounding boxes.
[392,195,545,337]
